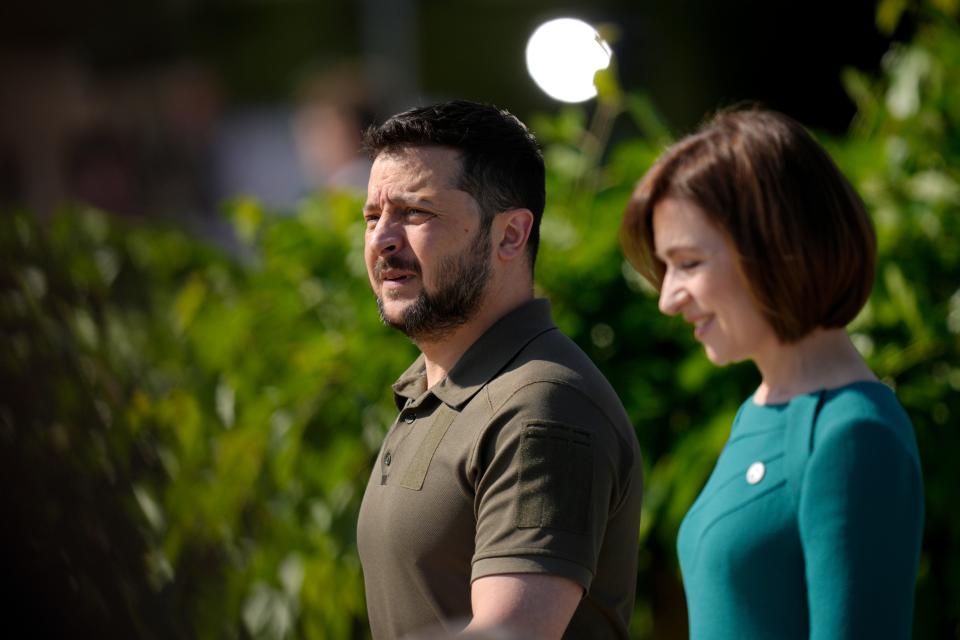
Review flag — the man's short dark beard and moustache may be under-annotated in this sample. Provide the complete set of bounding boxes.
[374,226,491,342]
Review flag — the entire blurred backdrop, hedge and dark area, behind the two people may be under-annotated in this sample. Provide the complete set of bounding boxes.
[0,0,960,638]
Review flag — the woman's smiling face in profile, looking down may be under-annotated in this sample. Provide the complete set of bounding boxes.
[653,198,779,365]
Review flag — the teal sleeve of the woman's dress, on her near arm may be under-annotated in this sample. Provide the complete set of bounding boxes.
[798,420,923,639]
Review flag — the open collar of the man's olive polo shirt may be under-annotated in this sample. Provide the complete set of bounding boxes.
[393,298,556,409]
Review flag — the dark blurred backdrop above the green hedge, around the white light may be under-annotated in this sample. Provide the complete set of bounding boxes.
[0,0,906,225]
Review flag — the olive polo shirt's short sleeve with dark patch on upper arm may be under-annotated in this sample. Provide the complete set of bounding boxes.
[471,382,621,591]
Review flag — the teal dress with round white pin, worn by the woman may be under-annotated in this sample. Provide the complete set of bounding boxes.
[677,382,923,640]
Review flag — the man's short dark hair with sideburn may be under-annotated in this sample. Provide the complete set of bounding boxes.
[363,100,546,271]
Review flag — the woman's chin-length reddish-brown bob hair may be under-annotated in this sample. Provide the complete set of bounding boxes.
[620,109,876,342]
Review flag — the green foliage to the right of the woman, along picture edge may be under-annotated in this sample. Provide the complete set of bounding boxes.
[832,11,960,638]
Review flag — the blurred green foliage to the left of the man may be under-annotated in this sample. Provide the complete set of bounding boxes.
[0,195,413,638]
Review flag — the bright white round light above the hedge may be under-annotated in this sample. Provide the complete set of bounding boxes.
[527,18,610,102]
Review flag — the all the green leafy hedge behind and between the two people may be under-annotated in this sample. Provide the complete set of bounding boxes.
[0,2,960,638]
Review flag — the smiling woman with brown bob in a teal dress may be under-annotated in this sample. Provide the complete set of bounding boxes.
[621,110,923,639]
